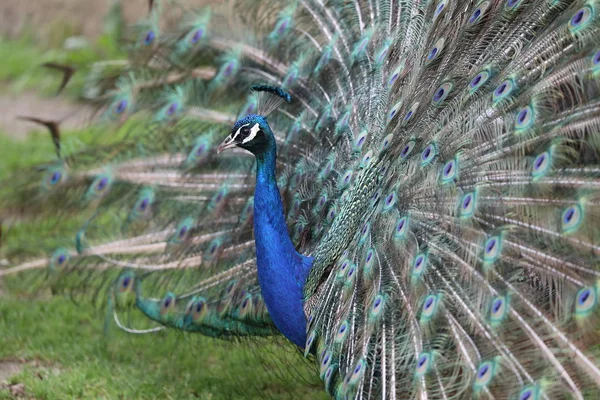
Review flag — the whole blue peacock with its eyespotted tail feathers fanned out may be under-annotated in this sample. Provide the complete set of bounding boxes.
[0,0,600,400]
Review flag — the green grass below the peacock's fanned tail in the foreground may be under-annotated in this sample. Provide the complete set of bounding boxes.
[0,297,325,399]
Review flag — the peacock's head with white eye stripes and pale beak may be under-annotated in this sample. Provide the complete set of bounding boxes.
[217,114,275,156]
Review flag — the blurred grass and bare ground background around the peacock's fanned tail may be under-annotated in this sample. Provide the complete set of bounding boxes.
[0,0,325,399]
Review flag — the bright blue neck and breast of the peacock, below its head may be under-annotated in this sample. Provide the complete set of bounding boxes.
[254,144,313,347]
